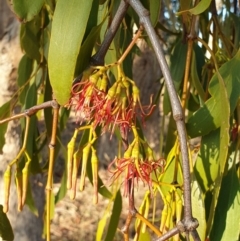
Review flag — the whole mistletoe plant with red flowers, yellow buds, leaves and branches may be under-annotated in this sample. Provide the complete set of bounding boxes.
[0,0,240,241]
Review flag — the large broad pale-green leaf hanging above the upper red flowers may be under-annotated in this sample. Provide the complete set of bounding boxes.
[48,0,93,105]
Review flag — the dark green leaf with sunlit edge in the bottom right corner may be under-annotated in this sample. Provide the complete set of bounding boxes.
[210,165,240,241]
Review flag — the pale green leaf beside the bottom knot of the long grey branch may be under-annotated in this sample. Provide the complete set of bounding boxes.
[191,175,207,240]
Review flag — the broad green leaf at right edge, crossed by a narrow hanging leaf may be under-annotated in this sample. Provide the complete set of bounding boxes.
[186,50,240,137]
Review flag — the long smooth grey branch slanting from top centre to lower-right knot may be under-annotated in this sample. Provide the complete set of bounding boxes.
[128,0,200,241]
